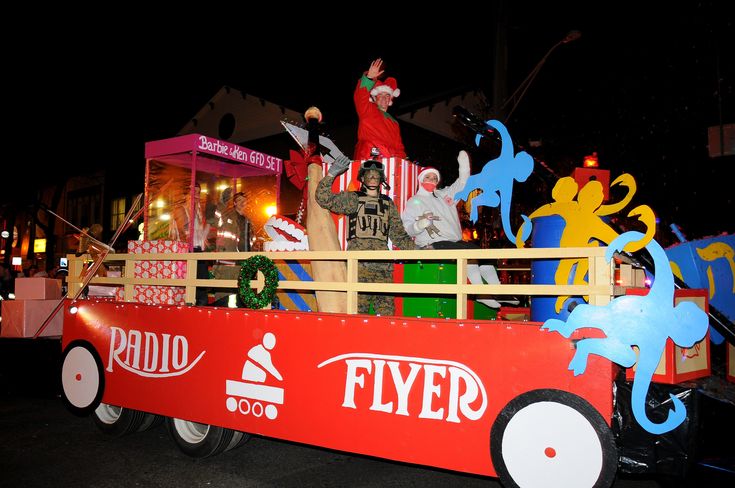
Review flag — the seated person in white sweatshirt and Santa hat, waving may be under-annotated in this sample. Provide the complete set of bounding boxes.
[401,151,517,308]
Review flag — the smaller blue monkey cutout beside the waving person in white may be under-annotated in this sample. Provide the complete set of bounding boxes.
[455,120,533,244]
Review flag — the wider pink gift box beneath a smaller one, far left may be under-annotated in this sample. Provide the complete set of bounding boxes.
[0,300,64,337]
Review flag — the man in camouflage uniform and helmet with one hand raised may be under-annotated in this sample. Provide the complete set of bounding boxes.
[316,155,415,315]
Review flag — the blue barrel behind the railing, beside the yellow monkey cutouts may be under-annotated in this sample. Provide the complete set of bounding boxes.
[531,215,584,322]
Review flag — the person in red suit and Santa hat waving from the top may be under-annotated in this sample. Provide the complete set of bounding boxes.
[354,58,406,161]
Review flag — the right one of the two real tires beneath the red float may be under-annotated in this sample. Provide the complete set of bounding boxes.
[166,418,236,458]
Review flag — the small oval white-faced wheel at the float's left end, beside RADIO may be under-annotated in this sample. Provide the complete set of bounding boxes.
[61,340,105,417]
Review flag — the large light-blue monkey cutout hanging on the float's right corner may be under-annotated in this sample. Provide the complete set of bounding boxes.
[542,232,709,434]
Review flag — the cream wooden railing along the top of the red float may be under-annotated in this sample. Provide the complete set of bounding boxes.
[68,247,637,319]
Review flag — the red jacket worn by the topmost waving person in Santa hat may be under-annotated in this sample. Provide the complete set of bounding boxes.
[353,75,406,160]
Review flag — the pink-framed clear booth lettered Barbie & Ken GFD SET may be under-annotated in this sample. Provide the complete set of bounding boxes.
[144,134,283,251]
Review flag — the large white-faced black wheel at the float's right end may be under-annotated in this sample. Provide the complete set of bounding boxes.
[490,390,618,488]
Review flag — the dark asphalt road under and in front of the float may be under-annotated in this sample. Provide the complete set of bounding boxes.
[0,339,728,488]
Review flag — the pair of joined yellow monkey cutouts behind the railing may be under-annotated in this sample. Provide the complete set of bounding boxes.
[516,173,656,313]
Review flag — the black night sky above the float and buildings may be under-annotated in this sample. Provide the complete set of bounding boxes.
[8,1,735,238]
